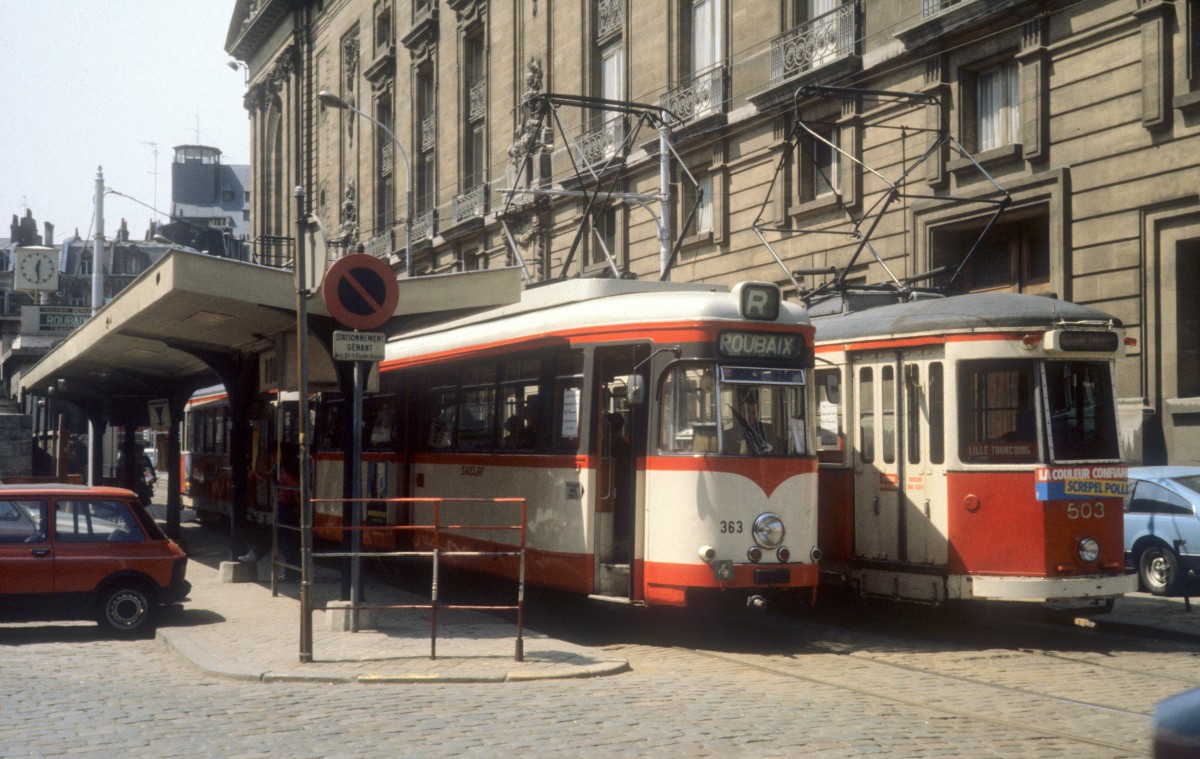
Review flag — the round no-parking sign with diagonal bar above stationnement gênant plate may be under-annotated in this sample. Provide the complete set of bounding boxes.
[320,253,400,329]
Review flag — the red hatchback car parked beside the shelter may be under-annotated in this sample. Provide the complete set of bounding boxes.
[0,484,191,635]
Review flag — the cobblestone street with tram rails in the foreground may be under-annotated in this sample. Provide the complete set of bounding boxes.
[0,583,1200,757]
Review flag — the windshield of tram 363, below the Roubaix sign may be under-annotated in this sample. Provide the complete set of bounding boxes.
[659,364,810,456]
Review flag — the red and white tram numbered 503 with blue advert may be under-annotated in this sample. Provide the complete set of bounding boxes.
[810,292,1136,603]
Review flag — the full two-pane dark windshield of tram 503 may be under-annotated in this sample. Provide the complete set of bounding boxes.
[959,359,1120,464]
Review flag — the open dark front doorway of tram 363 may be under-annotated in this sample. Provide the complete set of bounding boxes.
[592,346,646,599]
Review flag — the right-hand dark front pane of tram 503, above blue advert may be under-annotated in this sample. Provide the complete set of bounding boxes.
[1045,361,1120,461]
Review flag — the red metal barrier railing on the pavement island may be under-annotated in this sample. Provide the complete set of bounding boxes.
[278,489,527,662]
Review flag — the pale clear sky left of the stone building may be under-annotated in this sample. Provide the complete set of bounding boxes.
[0,0,250,244]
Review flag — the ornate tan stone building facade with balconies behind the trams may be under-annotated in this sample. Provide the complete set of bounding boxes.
[226,0,1200,462]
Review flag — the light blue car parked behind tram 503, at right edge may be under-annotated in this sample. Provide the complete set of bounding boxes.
[1124,466,1200,596]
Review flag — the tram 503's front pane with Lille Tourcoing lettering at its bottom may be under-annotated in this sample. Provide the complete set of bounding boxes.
[959,360,1038,464]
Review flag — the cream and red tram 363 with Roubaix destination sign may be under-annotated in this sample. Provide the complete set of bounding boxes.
[338,280,820,605]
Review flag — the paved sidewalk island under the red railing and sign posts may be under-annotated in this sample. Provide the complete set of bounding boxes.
[152,518,629,683]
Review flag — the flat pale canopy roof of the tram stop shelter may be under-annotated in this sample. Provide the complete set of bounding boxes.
[17,250,521,405]
